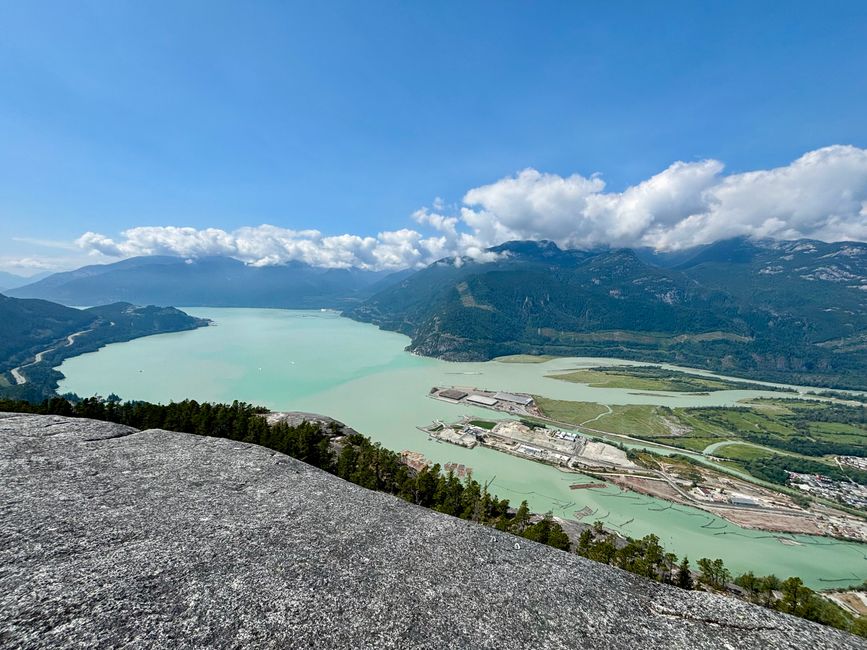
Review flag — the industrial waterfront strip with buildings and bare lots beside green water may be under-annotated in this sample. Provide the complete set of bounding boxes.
[419,387,867,544]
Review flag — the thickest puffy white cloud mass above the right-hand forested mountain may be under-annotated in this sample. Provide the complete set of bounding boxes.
[461,145,867,249]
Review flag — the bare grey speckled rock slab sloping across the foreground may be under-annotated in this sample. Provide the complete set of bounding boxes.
[0,414,862,650]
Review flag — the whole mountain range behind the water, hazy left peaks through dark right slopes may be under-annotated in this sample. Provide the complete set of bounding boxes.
[8,238,867,388]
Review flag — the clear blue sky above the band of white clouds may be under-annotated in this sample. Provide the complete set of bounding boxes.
[0,1,867,272]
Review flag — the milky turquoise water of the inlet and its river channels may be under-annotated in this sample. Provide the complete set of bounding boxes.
[59,308,867,588]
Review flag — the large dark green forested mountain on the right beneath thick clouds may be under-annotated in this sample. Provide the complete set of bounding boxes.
[350,239,867,388]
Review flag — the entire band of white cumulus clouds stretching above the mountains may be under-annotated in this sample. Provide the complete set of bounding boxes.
[77,145,867,269]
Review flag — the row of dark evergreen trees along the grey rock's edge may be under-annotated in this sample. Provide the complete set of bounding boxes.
[0,395,867,636]
